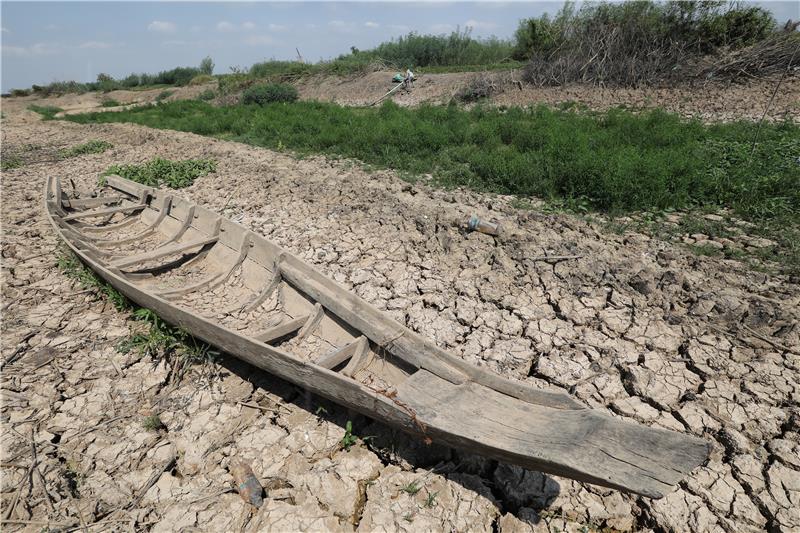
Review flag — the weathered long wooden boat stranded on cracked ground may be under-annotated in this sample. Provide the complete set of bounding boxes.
[45,176,709,498]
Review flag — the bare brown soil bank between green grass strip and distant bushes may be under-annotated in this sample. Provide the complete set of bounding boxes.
[298,71,800,121]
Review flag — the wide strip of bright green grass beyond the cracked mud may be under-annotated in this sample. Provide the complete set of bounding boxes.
[67,101,800,219]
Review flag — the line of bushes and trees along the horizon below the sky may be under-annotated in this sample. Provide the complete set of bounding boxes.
[6,0,798,95]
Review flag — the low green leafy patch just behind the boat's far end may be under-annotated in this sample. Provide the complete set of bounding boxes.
[103,157,217,189]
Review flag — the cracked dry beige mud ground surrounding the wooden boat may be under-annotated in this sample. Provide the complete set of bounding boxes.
[0,100,800,533]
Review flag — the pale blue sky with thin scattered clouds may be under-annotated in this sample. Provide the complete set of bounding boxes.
[0,1,800,92]
